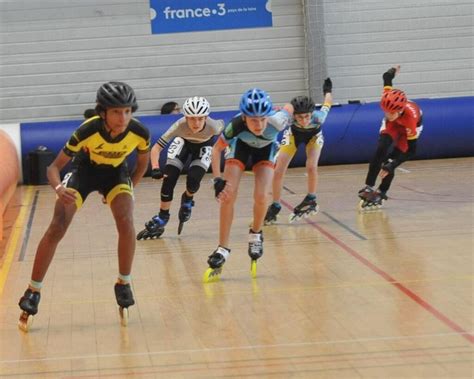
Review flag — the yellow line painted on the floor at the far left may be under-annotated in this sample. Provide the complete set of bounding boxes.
[0,186,33,296]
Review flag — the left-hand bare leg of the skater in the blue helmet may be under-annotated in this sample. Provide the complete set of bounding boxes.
[219,163,243,248]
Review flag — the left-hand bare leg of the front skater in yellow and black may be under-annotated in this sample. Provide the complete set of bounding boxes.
[31,200,79,284]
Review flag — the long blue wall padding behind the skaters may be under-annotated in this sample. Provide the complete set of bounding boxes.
[21,96,474,177]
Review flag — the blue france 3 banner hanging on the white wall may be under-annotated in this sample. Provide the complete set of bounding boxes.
[150,0,273,34]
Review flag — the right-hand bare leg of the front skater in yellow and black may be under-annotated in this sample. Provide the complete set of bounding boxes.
[110,193,135,275]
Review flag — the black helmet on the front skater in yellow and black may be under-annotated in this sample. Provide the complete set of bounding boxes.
[96,82,138,112]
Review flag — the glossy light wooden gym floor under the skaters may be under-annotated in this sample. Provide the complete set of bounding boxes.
[0,158,474,378]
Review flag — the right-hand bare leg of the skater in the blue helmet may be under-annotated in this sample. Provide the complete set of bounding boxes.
[252,161,273,232]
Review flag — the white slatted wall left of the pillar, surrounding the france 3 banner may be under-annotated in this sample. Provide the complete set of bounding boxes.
[0,0,308,123]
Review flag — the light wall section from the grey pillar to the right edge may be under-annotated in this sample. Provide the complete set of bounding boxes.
[305,0,474,102]
